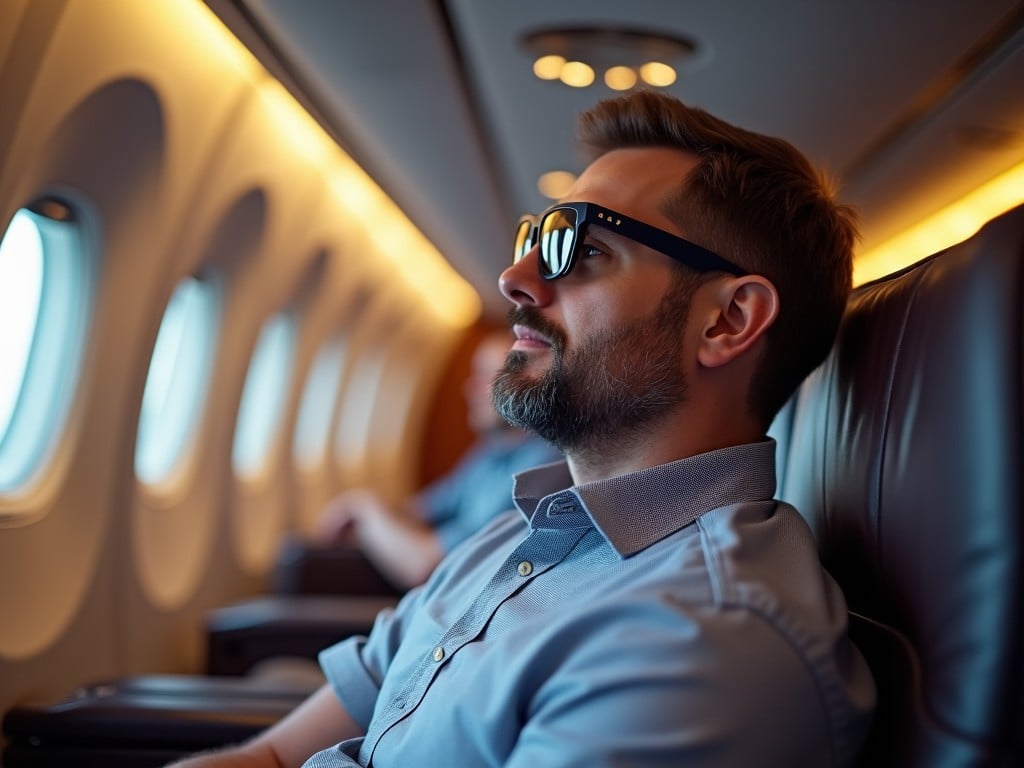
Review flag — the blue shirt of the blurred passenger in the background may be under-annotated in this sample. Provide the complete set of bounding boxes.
[417,431,561,553]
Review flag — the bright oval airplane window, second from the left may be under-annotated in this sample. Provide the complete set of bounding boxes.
[135,278,221,483]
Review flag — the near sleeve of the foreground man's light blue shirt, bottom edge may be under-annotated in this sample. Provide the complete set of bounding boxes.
[505,607,833,768]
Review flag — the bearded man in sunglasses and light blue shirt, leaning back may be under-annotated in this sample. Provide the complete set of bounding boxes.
[174,92,874,768]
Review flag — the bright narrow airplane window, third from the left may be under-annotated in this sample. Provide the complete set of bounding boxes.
[231,312,295,477]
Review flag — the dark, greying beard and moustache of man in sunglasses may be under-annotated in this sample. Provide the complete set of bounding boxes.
[492,278,694,455]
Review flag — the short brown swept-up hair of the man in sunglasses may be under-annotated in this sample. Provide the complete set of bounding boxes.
[579,90,857,428]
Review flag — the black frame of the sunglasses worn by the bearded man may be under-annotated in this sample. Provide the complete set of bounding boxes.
[513,203,748,280]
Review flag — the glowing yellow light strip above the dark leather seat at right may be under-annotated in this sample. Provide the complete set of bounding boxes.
[853,163,1024,285]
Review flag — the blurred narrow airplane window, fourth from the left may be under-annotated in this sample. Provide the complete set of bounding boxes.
[292,337,345,470]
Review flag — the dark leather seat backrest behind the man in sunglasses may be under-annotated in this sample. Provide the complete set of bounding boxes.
[774,208,1024,768]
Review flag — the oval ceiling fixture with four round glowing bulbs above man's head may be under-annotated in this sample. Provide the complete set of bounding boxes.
[521,27,696,90]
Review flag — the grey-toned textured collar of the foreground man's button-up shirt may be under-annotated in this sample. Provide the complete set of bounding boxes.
[513,438,775,557]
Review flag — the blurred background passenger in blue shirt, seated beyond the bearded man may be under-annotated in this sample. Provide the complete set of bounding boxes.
[314,332,560,591]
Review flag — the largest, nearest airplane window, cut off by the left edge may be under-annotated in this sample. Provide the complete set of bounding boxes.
[0,200,91,493]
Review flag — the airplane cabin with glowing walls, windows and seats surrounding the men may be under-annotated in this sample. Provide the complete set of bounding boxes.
[0,0,1024,768]
